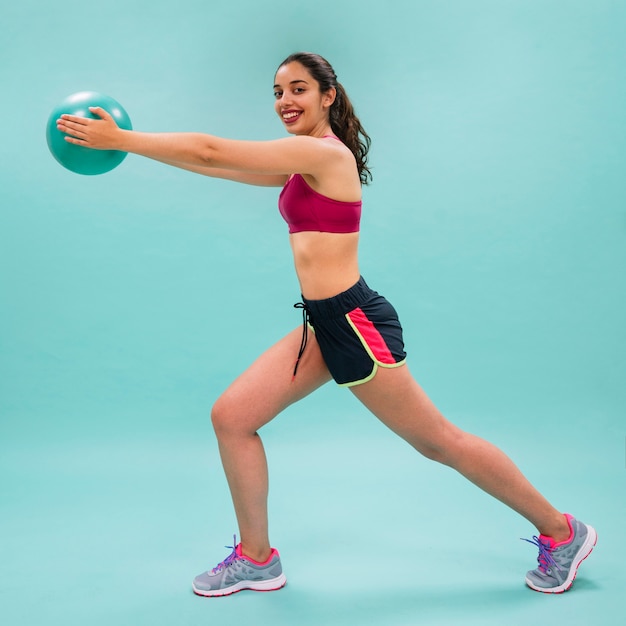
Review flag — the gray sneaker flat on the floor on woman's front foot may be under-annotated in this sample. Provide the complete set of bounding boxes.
[192,537,287,596]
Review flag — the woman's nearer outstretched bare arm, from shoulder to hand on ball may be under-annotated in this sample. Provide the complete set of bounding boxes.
[57,107,346,179]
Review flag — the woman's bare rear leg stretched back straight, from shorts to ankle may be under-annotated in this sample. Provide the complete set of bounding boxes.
[351,366,569,541]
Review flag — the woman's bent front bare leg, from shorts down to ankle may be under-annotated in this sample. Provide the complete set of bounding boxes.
[211,329,330,561]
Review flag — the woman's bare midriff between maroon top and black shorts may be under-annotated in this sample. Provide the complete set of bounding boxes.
[289,231,360,300]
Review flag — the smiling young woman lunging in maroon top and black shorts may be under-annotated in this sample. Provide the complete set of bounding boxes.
[58,53,596,596]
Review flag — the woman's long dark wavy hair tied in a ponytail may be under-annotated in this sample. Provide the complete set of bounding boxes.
[278,52,372,185]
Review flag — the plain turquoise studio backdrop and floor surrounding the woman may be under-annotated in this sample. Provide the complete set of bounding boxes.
[0,0,626,626]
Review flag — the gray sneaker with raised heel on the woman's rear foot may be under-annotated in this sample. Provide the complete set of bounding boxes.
[524,513,598,593]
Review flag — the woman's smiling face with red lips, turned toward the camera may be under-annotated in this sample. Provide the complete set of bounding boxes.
[274,61,336,137]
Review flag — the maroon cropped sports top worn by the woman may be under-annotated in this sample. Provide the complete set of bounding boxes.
[278,174,361,233]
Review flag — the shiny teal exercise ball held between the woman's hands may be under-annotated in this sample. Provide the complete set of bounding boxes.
[46,91,133,176]
